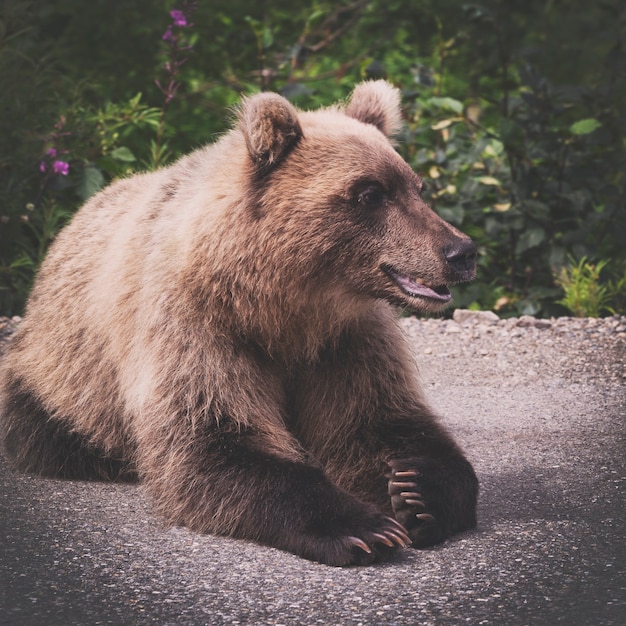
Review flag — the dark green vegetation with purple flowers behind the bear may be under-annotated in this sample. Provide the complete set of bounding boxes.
[0,0,626,316]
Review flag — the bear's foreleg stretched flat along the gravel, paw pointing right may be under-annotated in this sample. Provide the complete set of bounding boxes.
[139,417,411,566]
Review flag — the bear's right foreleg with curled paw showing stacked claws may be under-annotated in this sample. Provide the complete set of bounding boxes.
[293,316,478,547]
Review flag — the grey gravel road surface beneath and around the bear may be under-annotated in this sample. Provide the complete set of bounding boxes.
[0,312,626,626]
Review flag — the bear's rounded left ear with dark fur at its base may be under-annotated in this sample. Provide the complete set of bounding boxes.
[239,93,302,168]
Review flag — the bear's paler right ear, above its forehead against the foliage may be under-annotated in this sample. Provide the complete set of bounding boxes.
[346,80,402,137]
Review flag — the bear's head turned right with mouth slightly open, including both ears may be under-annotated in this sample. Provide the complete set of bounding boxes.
[234,81,476,312]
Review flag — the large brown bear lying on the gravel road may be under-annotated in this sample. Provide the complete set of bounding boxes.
[0,81,478,565]
